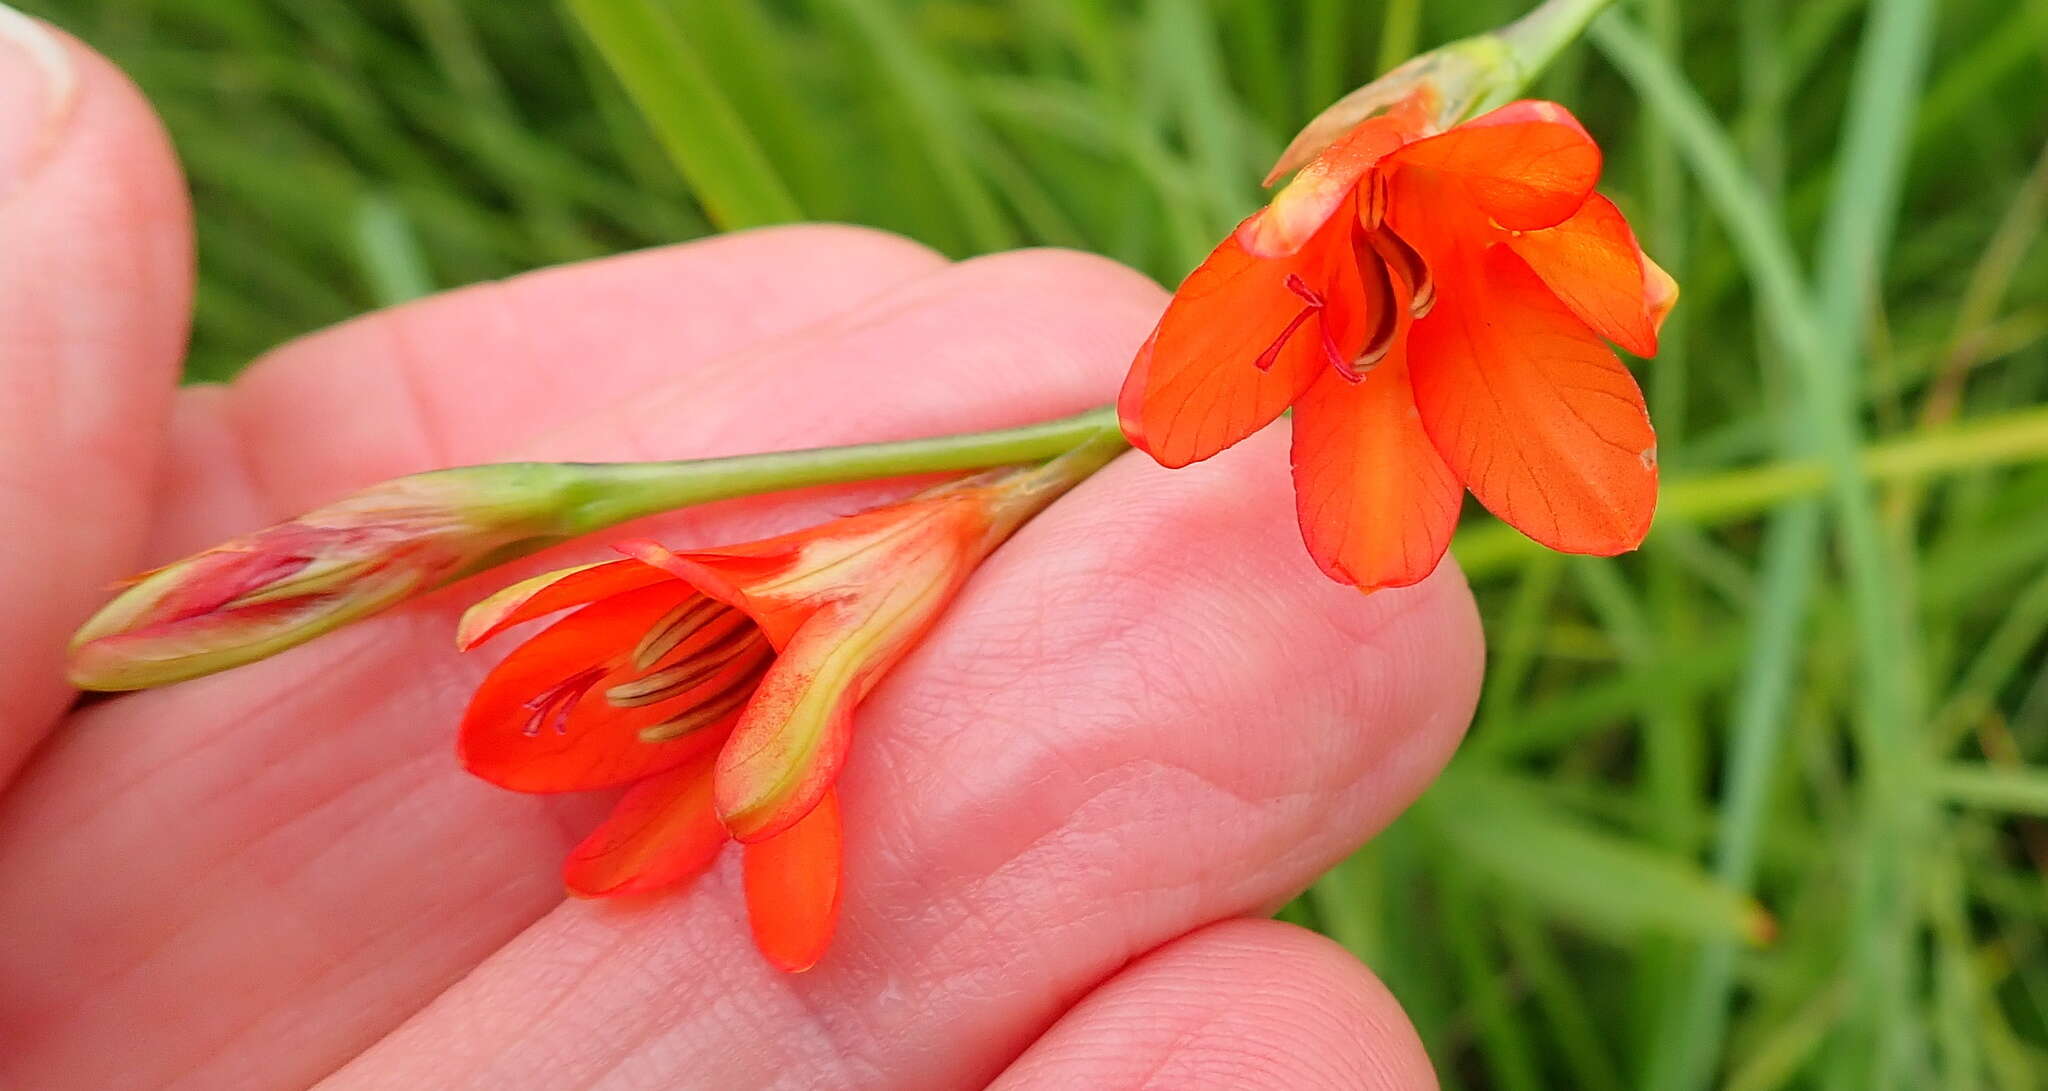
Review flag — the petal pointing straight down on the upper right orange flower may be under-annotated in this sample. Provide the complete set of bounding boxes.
[1294,356,1464,592]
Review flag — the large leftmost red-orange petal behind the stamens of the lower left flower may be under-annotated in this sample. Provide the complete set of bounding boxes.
[457,581,737,792]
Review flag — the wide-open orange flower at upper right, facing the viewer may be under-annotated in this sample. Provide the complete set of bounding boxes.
[1118,90,1677,590]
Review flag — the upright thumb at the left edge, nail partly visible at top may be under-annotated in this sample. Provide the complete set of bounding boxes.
[0,17,193,780]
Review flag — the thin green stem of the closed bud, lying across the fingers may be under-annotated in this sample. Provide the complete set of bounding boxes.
[553,407,1122,536]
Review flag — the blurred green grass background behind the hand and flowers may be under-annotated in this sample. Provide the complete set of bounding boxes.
[23,0,2048,1091]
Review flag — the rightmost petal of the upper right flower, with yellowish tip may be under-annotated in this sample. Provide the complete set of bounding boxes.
[1507,192,1677,356]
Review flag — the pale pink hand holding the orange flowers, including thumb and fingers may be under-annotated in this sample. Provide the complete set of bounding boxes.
[0,23,1481,1091]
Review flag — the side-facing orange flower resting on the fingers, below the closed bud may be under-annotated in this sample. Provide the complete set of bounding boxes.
[457,459,1100,970]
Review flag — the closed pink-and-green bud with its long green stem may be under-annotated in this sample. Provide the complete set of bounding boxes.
[70,407,1122,690]
